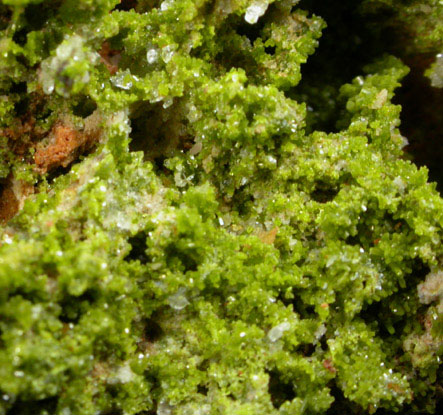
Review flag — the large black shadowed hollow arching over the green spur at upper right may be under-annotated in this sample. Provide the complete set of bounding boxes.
[287,0,443,193]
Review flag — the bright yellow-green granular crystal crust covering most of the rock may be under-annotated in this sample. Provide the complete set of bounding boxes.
[0,0,443,415]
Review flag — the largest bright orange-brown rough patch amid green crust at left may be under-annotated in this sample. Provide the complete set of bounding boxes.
[34,114,100,173]
